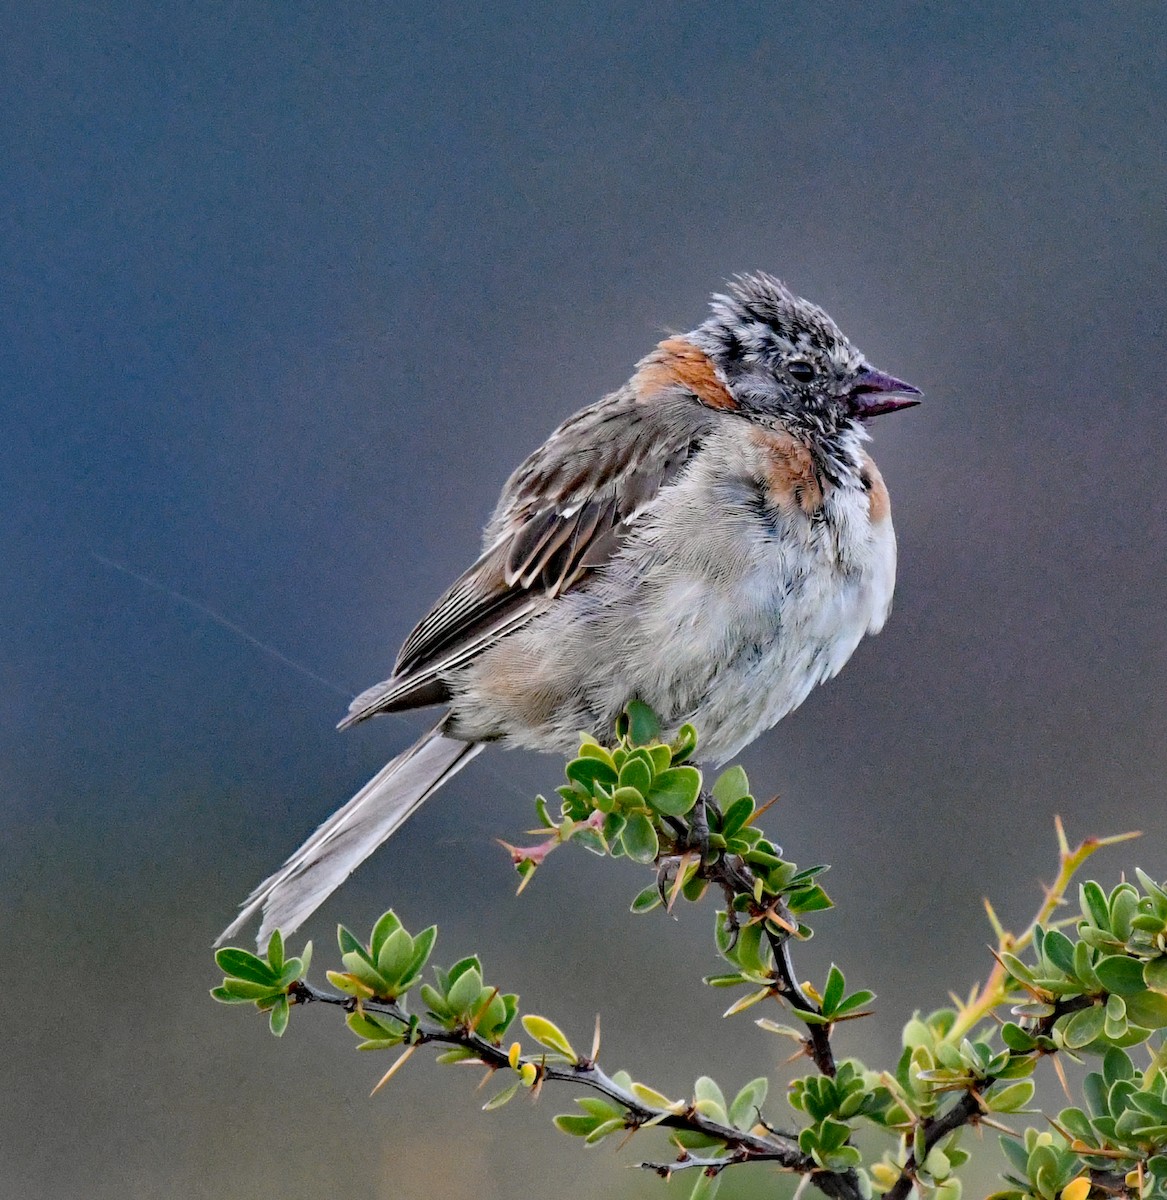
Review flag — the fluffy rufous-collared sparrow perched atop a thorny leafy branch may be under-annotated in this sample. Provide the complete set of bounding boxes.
[221,274,920,943]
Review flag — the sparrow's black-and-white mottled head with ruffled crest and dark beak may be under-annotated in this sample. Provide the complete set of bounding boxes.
[688,272,921,460]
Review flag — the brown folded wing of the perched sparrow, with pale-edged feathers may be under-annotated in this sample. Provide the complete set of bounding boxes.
[341,385,712,728]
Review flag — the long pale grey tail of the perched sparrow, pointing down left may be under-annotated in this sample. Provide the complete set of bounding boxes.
[215,725,483,948]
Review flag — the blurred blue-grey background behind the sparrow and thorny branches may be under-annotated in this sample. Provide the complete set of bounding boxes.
[0,0,1167,1200]
